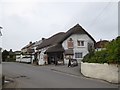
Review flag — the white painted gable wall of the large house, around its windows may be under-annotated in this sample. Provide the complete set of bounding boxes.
[62,34,94,64]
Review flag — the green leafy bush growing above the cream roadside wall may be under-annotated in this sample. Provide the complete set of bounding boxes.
[82,37,120,64]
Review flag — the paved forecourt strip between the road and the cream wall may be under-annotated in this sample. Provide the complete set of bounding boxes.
[37,63,117,85]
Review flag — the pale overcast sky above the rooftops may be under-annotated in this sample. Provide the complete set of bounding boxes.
[0,0,118,51]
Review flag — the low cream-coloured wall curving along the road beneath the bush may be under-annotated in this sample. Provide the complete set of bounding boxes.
[81,62,120,83]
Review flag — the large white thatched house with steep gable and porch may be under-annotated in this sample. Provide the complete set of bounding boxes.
[37,24,95,65]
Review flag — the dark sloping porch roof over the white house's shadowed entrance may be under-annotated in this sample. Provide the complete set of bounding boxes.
[45,44,64,53]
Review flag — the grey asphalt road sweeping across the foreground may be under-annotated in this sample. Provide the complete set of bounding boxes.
[2,62,117,88]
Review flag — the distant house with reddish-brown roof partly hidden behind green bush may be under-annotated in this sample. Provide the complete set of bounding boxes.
[95,40,109,51]
